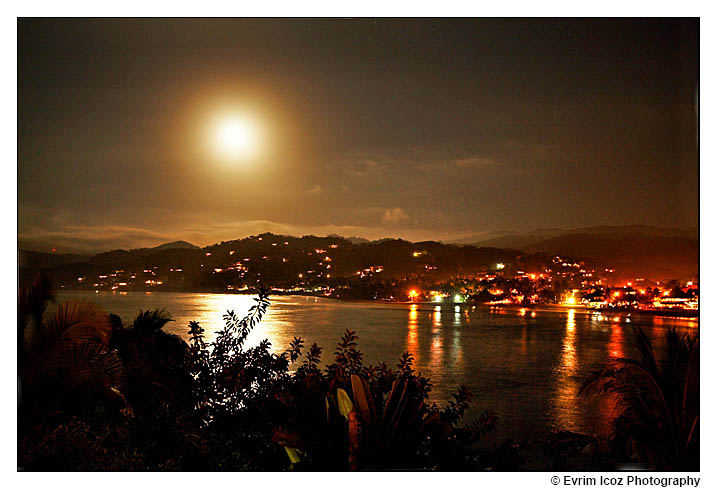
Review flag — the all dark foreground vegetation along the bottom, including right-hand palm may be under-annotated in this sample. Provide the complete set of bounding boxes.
[17,277,699,471]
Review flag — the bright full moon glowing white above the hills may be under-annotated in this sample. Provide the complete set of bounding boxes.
[211,115,258,161]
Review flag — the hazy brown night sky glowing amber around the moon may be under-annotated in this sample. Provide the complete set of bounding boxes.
[18,19,699,251]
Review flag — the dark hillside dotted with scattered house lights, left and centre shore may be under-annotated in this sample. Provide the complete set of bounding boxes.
[19,233,524,291]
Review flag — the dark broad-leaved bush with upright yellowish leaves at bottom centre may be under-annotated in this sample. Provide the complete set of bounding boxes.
[274,330,497,469]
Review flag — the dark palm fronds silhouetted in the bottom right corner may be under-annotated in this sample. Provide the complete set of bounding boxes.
[582,327,700,471]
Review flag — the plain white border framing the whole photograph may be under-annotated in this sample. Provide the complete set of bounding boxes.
[7,4,718,490]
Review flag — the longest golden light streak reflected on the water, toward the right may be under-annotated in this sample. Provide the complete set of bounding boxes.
[552,309,580,431]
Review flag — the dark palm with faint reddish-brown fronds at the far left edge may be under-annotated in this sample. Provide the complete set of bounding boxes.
[18,276,126,468]
